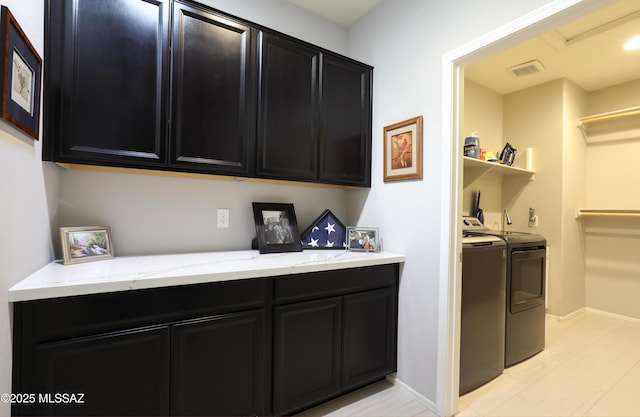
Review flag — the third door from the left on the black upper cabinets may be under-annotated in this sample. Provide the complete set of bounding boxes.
[257,33,320,180]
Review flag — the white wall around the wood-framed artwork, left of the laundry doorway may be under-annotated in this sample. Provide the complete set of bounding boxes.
[349,0,547,411]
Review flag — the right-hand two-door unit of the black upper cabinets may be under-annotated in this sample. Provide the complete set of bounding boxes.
[257,33,372,186]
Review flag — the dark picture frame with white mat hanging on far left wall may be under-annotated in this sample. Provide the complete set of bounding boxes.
[0,6,42,140]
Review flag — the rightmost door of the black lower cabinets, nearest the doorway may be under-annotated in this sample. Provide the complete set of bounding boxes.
[342,288,397,389]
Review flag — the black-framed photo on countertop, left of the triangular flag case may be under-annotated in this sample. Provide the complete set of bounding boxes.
[252,202,302,253]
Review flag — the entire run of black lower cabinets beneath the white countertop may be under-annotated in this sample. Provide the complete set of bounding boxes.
[11,264,399,416]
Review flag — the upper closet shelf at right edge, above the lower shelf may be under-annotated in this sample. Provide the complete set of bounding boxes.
[576,106,640,143]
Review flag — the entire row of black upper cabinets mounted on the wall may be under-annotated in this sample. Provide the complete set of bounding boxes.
[43,0,372,186]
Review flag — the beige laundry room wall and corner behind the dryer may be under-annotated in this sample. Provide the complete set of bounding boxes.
[503,79,586,316]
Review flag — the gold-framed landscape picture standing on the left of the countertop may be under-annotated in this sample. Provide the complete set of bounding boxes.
[60,226,113,265]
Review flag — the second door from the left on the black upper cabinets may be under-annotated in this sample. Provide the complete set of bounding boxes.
[170,2,256,176]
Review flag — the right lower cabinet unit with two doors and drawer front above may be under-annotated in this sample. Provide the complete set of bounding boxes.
[273,265,398,415]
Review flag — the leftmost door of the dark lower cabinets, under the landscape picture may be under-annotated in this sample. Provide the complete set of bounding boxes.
[27,326,169,416]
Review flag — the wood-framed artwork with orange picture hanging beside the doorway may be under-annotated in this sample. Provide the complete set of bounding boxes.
[384,116,422,182]
